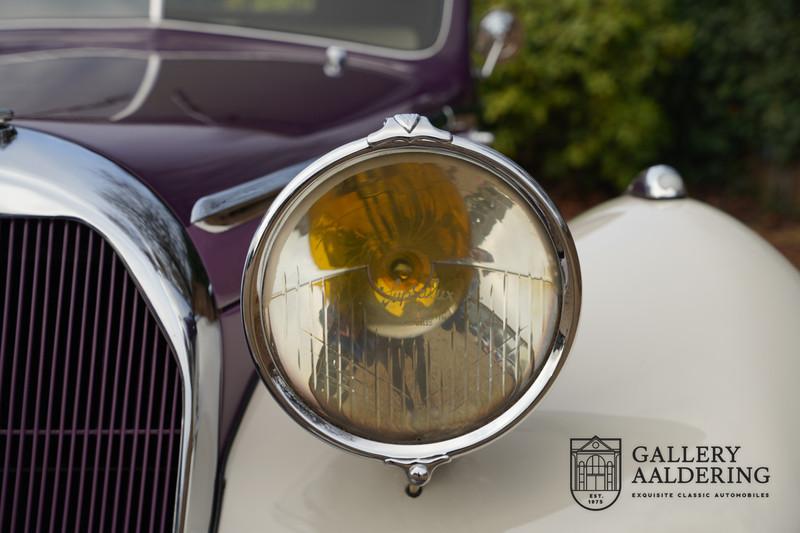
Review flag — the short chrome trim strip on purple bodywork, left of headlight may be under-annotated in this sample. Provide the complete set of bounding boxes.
[191,159,314,233]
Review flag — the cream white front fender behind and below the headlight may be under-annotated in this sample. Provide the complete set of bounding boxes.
[220,189,800,533]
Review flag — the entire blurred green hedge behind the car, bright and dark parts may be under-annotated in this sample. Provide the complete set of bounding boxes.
[473,0,800,195]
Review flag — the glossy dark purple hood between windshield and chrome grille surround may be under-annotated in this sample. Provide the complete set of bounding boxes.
[0,30,468,307]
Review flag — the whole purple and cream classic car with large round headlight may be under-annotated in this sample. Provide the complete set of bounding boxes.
[0,0,800,532]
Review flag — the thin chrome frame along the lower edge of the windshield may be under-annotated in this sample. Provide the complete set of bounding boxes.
[0,0,453,60]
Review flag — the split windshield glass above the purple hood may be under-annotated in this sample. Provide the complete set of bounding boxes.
[0,0,446,50]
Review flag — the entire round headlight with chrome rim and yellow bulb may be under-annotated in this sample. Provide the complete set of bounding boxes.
[242,115,580,492]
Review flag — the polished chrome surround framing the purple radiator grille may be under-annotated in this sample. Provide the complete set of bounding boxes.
[0,128,222,531]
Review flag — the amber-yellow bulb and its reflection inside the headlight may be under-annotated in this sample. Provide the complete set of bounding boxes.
[308,162,473,338]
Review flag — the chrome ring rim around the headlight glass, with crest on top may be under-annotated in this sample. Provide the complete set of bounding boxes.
[241,115,581,465]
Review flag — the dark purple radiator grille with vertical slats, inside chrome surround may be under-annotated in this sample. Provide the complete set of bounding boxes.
[0,217,183,532]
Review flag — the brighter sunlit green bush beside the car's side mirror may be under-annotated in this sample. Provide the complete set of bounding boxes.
[474,0,693,188]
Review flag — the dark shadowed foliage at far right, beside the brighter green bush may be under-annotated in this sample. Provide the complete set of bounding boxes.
[666,0,800,188]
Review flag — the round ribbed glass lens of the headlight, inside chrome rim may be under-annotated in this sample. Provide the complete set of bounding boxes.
[258,149,561,444]
